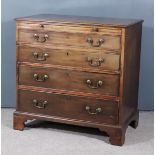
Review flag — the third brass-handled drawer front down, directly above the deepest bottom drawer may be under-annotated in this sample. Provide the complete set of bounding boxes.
[19,65,119,96]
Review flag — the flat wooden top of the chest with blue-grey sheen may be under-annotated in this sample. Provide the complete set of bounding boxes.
[16,14,143,27]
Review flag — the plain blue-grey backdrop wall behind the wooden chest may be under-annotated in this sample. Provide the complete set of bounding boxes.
[2,0,154,110]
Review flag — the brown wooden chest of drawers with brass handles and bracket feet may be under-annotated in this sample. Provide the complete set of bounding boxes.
[14,14,143,145]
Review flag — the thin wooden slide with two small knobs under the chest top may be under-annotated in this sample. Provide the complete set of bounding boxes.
[17,21,122,36]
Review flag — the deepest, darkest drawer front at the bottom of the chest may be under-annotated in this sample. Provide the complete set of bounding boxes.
[17,90,118,124]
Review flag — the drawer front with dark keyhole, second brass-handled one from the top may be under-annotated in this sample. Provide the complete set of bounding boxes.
[18,46,120,71]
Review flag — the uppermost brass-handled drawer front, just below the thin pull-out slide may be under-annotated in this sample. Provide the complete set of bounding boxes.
[17,29,120,50]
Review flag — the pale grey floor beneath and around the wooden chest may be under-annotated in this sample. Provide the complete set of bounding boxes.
[1,109,154,155]
